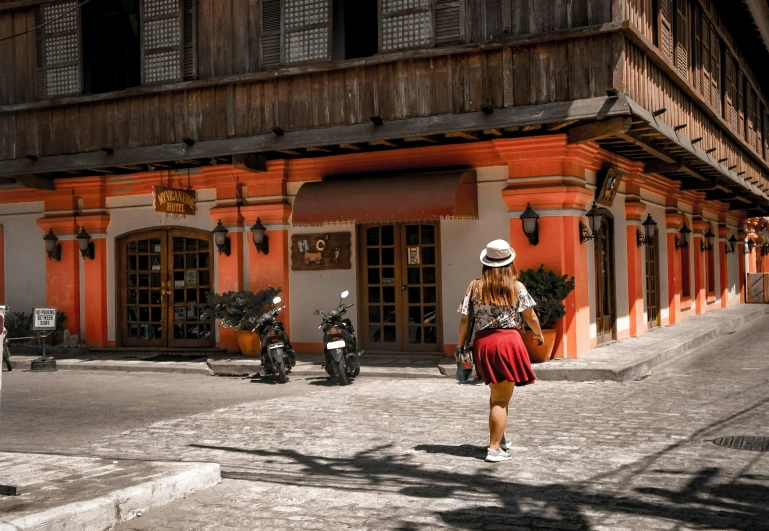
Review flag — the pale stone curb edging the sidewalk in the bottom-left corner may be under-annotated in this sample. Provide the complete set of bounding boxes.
[0,463,222,531]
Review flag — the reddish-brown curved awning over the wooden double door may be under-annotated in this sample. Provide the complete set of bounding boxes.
[293,169,478,226]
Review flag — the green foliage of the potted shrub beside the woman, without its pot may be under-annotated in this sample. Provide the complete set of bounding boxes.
[518,265,575,328]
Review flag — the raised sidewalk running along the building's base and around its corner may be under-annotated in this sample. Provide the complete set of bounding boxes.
[11,304,769,382]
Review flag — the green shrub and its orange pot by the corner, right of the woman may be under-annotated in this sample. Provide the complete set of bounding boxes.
[518,265,574,362]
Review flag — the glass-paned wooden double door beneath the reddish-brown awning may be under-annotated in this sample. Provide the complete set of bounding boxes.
[358,223,443,352]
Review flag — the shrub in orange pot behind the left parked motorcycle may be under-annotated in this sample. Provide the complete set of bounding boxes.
[203,287,281,356]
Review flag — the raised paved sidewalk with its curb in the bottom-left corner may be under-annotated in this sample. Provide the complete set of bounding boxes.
[0,452,221,531]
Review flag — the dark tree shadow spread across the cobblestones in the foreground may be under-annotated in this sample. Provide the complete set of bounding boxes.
[193,445,769,531]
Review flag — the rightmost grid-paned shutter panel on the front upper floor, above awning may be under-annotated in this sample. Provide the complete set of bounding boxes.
[379,0,435,52]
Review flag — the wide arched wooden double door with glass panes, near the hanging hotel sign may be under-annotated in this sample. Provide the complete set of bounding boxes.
[115,227,216,348]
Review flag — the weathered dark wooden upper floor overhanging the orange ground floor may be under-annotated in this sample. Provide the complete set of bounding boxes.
[0,0,769,212]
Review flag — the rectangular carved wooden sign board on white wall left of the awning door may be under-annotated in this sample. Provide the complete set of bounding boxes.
[291,232,352,271]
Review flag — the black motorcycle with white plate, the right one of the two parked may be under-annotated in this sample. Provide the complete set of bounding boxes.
[313,291,363,385]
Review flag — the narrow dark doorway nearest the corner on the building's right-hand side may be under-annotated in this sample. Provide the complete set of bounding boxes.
[593,209,617,345]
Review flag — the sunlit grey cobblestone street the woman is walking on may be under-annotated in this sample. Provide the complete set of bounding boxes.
[88,317,769,531]
